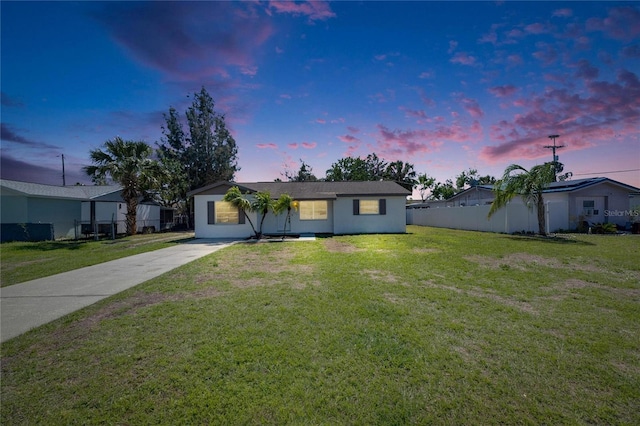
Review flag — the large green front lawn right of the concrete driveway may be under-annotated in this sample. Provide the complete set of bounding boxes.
[0,227,640,425]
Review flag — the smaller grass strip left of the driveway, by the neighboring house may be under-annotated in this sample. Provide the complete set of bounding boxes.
[0,232,193,287]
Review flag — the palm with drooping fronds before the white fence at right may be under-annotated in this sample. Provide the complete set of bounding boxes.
[488,163,556,235]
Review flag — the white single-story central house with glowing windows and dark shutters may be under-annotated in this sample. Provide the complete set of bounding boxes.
[189,181,411,238]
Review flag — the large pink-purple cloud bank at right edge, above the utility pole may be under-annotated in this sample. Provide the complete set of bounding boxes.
[480,68,640,162]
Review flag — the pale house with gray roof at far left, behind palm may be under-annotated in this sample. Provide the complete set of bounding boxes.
[0,179,160,241]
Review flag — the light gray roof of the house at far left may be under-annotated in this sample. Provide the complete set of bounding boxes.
[0,179,120,200]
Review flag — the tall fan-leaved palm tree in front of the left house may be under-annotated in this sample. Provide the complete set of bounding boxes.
[84,137,163,235]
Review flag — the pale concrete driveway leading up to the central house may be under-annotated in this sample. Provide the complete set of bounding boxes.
[0,239,235,342]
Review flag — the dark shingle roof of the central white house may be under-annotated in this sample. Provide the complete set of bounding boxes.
[189,181,411,200]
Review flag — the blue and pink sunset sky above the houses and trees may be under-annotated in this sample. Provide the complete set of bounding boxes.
[0,1,640,200]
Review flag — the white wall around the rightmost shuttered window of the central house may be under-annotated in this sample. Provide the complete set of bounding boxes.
[333,197,407,235]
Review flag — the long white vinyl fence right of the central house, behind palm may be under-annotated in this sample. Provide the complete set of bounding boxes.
[407,201,569,234]
